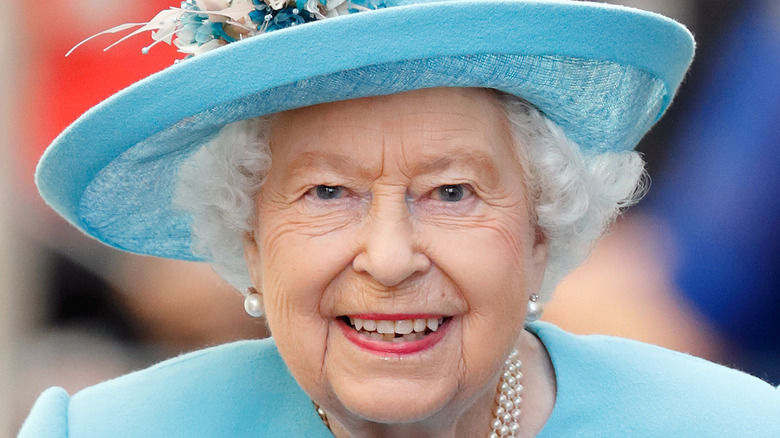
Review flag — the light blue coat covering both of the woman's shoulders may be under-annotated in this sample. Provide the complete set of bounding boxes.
[19,323,780,438]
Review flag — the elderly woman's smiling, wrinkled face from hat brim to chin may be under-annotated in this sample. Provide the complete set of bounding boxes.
[245,88,546,430]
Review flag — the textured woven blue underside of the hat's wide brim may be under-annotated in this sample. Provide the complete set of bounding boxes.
[79,55,668,260]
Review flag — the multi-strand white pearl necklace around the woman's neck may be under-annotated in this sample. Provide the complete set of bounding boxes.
[312,350,523,438]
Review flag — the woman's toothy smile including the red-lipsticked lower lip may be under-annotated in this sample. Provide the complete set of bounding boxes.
[337,315,452,355]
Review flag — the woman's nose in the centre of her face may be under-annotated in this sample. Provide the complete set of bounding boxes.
[352,192,430,287]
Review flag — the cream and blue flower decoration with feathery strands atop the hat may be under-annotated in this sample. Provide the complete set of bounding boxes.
[66,0,384,57]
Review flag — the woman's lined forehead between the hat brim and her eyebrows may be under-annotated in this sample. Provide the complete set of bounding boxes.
[271,88,516,176]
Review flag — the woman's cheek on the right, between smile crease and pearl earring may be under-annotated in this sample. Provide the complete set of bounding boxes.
[420,218,533,385]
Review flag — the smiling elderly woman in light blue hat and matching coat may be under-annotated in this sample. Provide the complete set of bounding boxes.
[20,0,780,438]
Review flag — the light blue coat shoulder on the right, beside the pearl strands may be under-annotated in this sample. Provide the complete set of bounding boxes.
[530,323,780,437]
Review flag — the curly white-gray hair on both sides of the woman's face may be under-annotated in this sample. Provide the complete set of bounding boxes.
[174,94,647,302]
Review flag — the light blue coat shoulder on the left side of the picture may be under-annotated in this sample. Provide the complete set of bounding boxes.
[19,339,330,438]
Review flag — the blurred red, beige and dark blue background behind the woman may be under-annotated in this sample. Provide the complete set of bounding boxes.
[0,0,780,437]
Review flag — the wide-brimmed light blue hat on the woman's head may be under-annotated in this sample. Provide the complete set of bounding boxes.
[36,0,694,260]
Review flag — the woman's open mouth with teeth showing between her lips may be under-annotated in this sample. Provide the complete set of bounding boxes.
[339,315,452,342]
